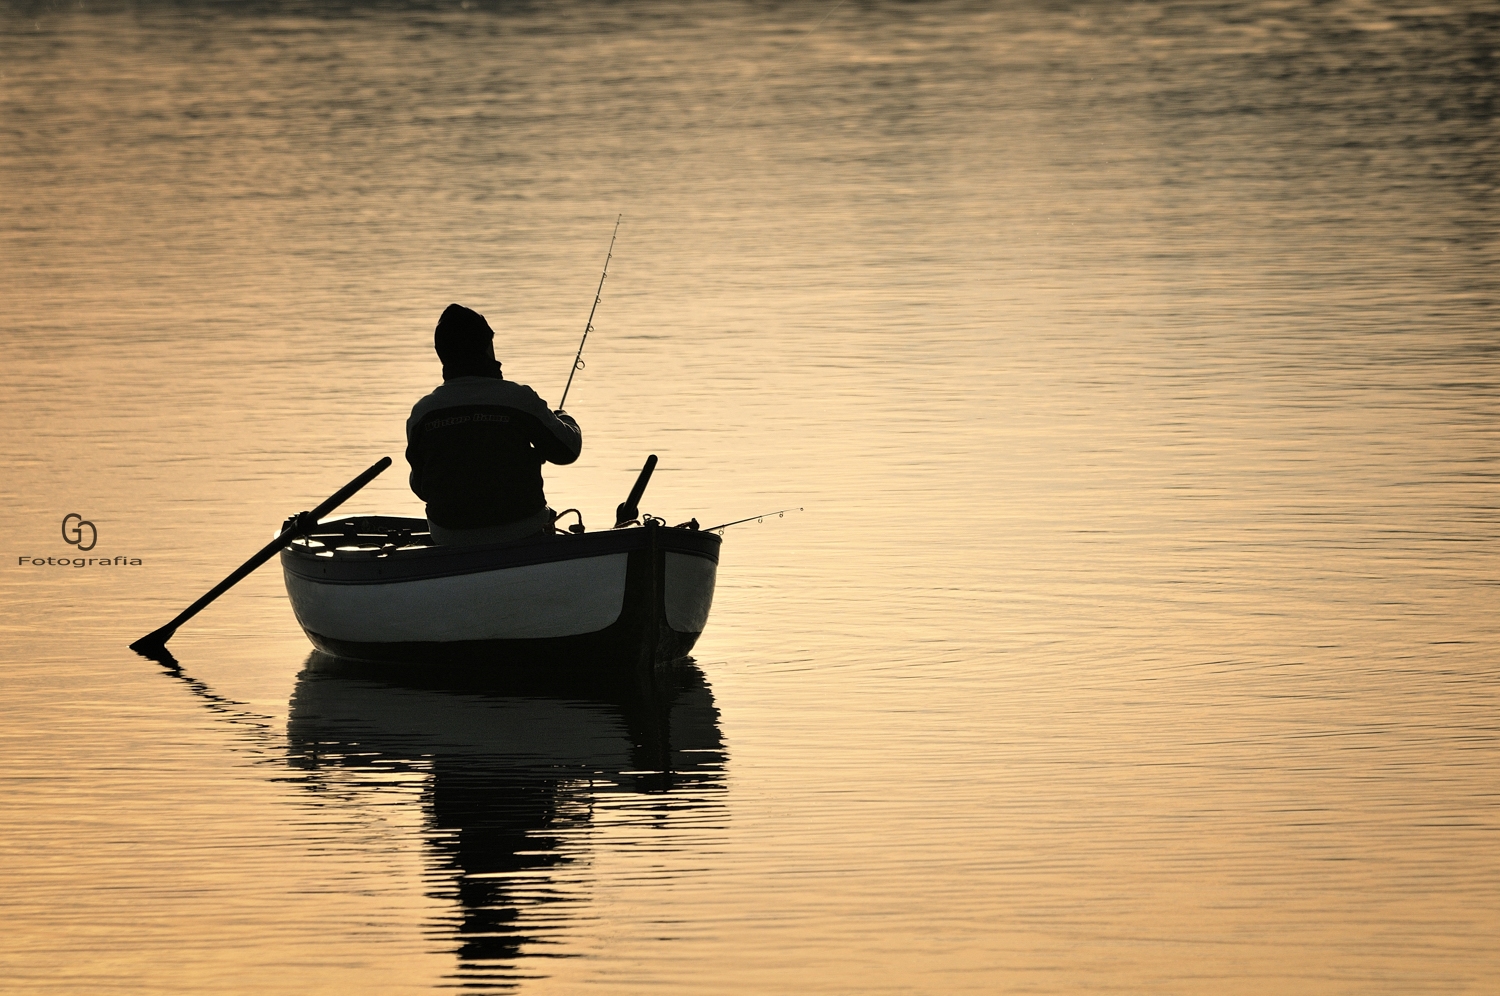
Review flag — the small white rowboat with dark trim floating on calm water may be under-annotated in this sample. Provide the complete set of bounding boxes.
[281,515,722,666]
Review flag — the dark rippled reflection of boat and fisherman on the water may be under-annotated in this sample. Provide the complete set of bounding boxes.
[287,653,725,989]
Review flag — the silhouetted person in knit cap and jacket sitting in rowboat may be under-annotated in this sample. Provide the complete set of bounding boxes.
[407,305,584,545]
